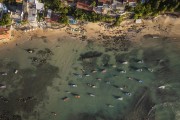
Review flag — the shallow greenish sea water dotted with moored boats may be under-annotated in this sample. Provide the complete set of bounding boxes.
[0,36,180,120]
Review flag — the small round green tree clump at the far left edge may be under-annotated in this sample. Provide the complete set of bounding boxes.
[0,13,11,26]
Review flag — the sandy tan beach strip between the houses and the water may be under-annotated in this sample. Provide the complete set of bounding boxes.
[0,15,180,49]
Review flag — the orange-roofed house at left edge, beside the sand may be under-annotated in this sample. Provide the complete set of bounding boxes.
[0,27,11,40]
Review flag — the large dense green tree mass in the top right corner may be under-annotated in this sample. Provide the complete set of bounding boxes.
[132,0,180,19]
